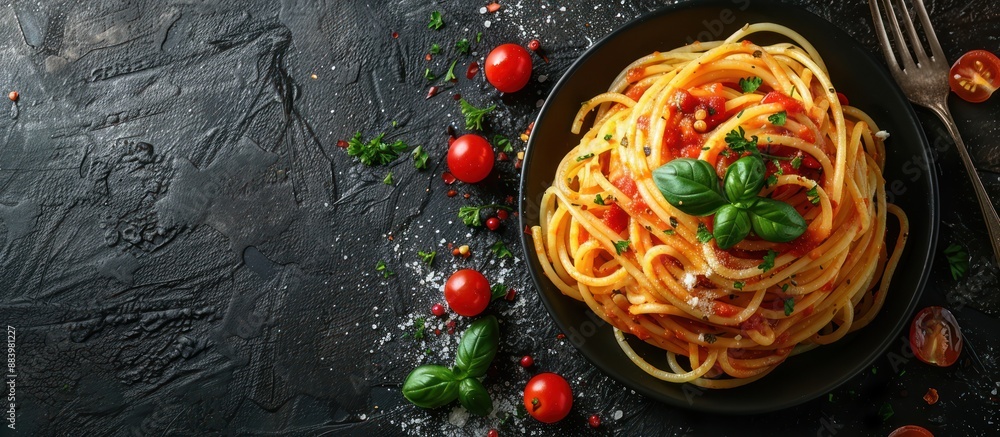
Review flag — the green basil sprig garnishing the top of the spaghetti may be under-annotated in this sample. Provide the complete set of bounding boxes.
[653,155,806,249]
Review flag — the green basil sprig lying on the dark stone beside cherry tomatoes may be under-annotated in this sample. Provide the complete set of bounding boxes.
[403,316,500,416]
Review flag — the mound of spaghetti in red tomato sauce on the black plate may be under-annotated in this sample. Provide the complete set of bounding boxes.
[532,23,908,388]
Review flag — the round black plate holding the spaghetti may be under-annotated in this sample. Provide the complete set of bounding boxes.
[519,0,938,414]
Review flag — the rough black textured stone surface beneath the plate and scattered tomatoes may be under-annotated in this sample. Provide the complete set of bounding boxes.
[0,0,1000,436]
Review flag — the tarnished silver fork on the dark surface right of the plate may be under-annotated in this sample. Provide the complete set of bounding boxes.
[868,0,1000,263]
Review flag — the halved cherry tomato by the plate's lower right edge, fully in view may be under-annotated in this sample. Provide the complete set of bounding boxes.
[910,306,962,367]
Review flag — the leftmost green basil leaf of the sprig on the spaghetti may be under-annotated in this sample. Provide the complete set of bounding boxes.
[653,158,729,216]
